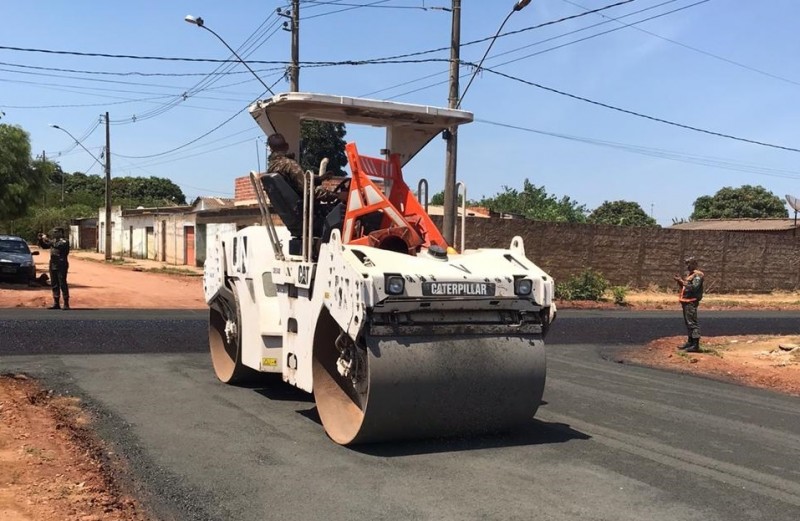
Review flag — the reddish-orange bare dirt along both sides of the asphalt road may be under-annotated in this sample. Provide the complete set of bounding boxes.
[0,252,800,521]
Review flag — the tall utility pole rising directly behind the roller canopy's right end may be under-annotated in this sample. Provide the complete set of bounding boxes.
[442,0,461,246]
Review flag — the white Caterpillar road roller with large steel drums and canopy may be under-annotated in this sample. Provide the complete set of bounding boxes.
[204,92,555,445]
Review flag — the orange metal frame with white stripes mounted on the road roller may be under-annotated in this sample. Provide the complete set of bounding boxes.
[342,143,447,255]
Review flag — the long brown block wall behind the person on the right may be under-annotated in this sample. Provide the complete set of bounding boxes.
[434,217,800,293]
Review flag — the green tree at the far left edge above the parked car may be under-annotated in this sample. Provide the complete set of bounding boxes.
[0,123,48,220]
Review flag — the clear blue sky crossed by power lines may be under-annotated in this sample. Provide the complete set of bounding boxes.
[0,0,800,226]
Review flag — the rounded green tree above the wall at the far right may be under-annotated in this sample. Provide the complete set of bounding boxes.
[689,185,789,221]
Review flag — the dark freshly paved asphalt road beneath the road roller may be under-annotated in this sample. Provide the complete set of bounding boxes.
[0,310,800,521]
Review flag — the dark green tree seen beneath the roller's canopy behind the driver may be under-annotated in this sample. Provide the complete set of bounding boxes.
[300,120,347,175]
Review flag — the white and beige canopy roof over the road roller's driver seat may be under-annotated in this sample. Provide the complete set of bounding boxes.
[249,92,472,165]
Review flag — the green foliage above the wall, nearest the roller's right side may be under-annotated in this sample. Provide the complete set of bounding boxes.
[478,179,586,222]
